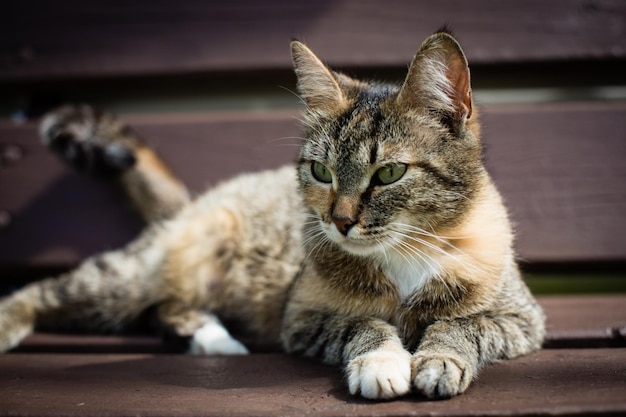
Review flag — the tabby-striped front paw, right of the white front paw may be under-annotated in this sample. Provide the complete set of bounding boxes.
[411,352,472,398]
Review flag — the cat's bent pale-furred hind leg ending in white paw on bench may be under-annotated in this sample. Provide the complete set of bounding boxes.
[157,207,248,355]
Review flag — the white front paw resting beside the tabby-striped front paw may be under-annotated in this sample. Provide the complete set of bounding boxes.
[346,343,411,399]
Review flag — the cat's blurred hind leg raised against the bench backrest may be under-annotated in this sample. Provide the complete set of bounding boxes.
[40,105,189,222]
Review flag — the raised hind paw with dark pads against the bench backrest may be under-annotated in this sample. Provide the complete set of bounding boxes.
[40,105,138,176]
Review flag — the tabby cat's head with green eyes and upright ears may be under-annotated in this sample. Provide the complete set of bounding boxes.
[291,32,485,255]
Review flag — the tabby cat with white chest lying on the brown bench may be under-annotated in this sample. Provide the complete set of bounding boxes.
[0,31,545,399]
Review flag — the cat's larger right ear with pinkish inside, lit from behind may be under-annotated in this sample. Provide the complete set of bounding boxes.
[398,32,472,122]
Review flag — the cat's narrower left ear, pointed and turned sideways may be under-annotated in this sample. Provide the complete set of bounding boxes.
[291,41,346,111]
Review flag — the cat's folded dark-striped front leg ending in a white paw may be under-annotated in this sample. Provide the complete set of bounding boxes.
[282,308,411,399]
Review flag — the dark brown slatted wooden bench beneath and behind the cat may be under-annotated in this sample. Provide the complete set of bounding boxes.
[0,0,626,417]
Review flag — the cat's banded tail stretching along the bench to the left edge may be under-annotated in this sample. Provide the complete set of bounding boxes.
[0,225,165,352]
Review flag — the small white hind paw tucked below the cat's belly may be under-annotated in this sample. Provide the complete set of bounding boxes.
[188,321,249,355]
